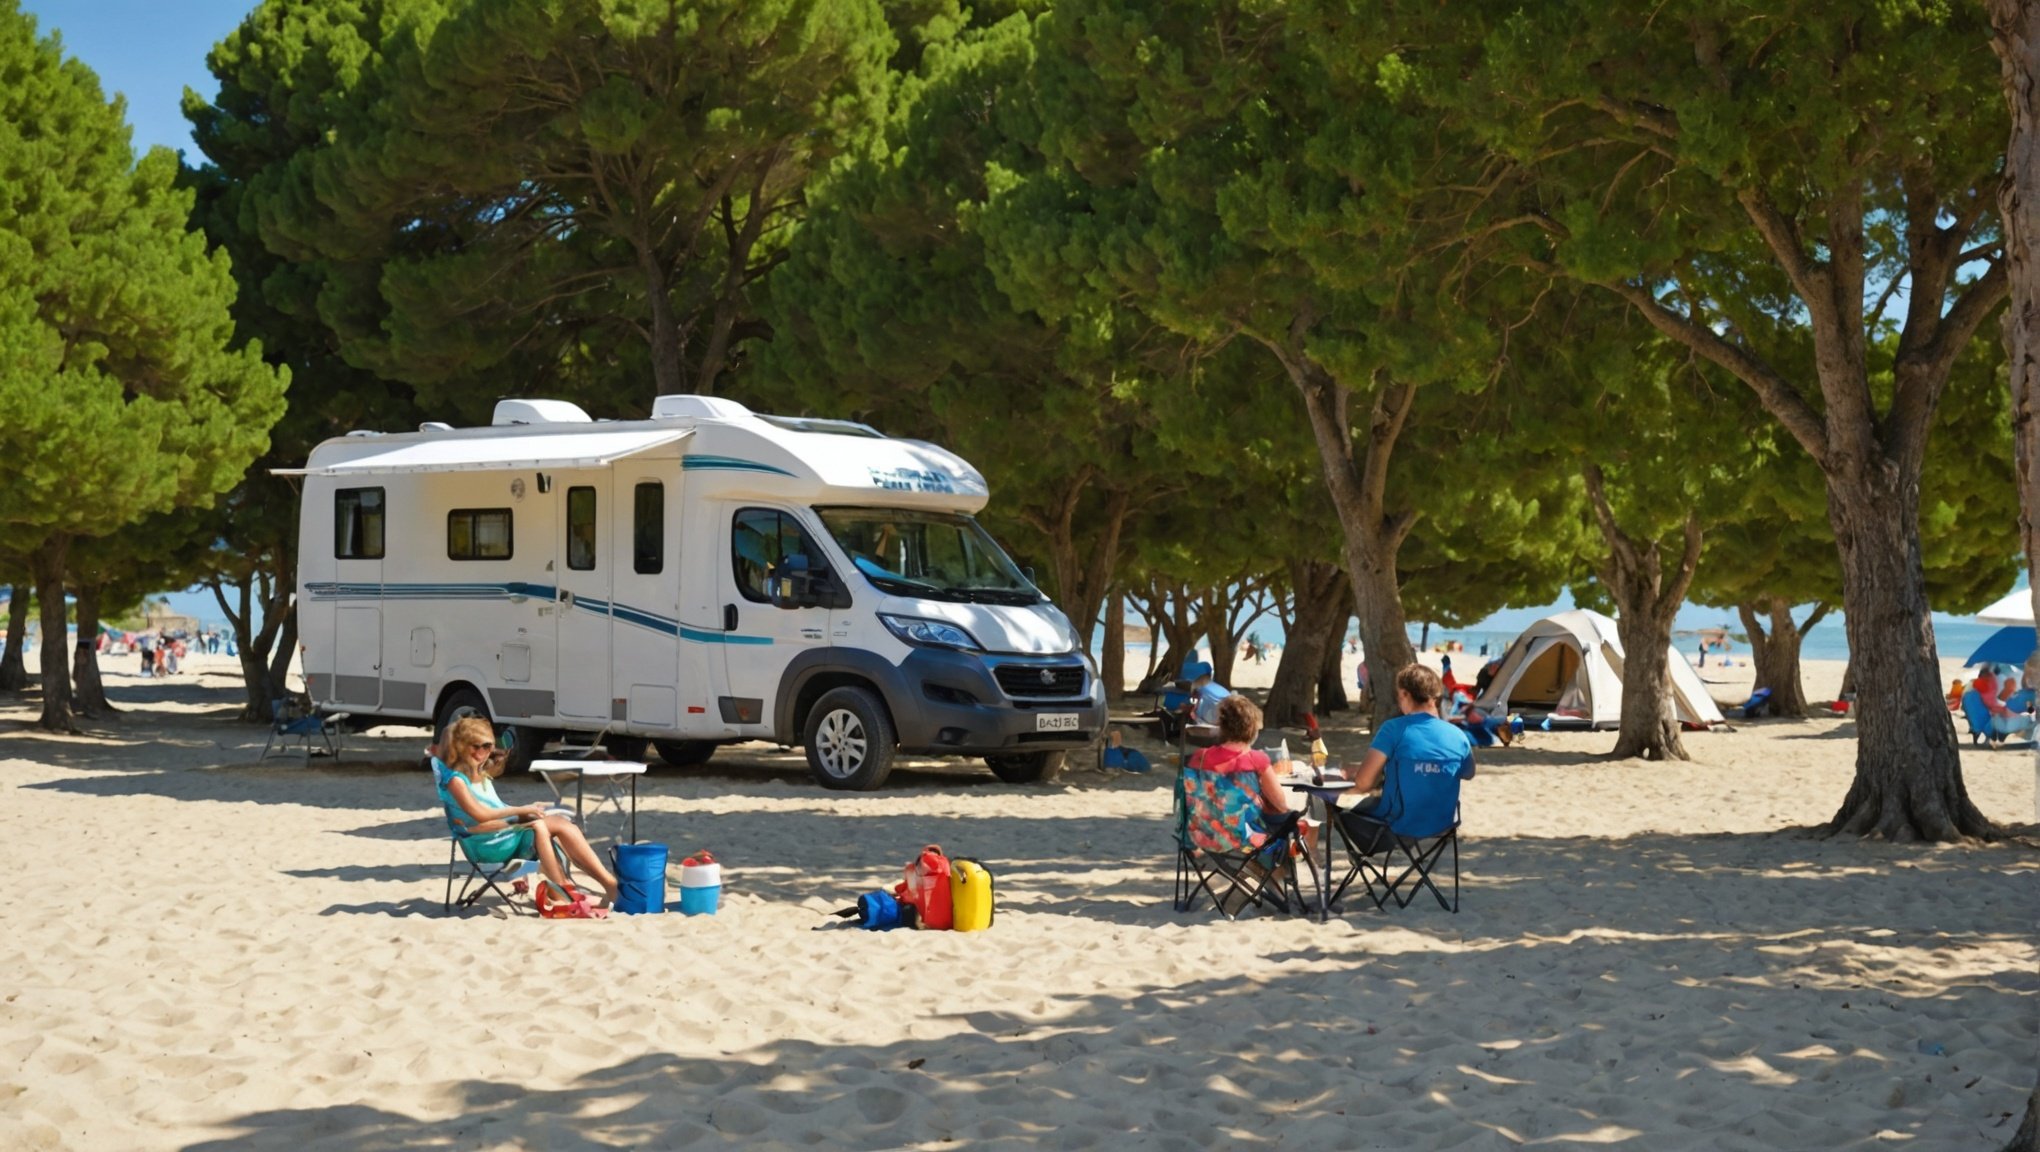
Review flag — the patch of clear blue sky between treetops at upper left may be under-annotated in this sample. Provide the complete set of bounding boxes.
[20,0,255,163]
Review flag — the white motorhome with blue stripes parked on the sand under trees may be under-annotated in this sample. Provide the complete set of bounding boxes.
[288,396,1106,789]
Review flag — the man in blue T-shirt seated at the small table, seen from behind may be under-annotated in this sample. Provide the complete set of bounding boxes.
[1338,665,1473,852]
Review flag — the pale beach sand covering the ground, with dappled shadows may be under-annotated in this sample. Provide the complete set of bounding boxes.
[0,659,2040,1152]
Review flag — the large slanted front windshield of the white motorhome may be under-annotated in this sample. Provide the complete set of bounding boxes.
[816,508,1040,606]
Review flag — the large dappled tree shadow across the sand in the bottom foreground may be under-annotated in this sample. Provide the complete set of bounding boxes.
[188,930,2032,1152]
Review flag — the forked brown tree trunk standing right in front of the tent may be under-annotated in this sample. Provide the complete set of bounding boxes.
[1581,465,1699,761]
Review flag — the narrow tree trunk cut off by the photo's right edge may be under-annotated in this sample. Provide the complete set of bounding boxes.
[1991,0,2040,1152]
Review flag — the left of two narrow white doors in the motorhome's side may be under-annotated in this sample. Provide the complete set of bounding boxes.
[553,469,616,722]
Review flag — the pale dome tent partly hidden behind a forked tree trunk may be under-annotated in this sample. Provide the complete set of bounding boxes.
[1479,608,1722,728]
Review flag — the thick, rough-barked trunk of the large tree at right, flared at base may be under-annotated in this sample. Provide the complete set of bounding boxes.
[1828,481,1997,840]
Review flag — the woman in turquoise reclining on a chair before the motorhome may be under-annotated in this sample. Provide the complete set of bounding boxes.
[441,716,616,907]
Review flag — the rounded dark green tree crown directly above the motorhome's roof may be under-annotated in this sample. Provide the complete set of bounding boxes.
[216,0,894,416]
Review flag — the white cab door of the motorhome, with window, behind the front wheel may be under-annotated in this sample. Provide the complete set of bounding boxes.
[716,506,828,736]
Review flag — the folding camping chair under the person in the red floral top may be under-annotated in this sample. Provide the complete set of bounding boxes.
[1173,767,1318,920]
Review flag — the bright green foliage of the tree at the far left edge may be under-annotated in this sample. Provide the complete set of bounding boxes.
[0,2,288,538]
